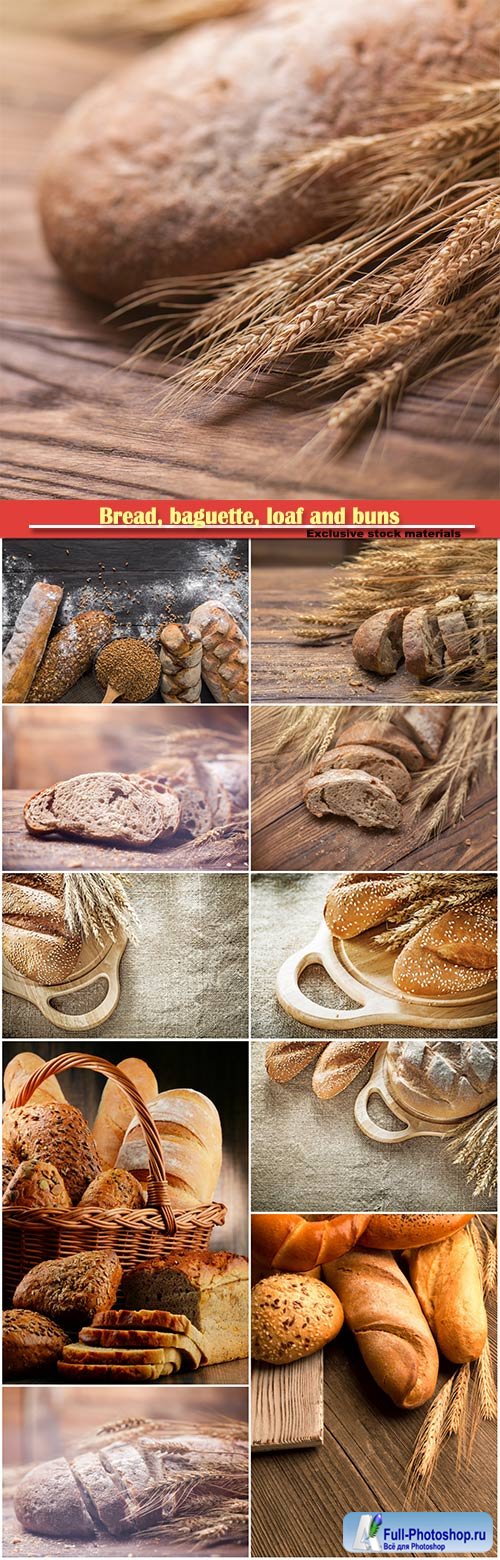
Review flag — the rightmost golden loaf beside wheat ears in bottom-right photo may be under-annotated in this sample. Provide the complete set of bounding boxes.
[408,1229,488,1365]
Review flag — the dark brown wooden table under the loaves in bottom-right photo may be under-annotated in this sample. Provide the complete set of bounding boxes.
[252,1291,497,1557]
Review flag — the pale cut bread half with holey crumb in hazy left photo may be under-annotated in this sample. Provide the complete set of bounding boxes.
[23,771,163,846]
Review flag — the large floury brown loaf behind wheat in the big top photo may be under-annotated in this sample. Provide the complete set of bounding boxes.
[40,0,497,301]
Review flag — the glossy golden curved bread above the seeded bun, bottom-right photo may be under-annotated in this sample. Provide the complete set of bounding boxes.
[252,1214,369,1273]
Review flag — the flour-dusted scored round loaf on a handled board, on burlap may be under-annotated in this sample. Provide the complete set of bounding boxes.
[385,1041,497,1122]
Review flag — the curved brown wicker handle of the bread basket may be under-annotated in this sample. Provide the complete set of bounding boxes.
[9,1051,176,1236]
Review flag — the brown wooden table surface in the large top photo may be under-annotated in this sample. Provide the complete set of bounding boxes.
[2,28,497,504]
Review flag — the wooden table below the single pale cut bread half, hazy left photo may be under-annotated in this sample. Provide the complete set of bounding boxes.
[3,791,248,872]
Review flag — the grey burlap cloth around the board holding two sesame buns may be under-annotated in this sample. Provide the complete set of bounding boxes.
[252,872,497,1041]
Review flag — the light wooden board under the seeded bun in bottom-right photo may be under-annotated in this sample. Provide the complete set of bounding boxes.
[252,1351,322,1452]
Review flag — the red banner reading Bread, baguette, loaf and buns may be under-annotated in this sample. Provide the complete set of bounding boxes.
[0,498,500,540]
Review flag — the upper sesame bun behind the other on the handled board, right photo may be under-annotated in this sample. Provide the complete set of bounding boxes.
[324,872,408,938]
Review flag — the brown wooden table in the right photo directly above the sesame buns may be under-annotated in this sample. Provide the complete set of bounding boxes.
[252,710,497,872]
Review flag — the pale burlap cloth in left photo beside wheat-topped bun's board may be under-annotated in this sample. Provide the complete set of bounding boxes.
[3,872,248,1044]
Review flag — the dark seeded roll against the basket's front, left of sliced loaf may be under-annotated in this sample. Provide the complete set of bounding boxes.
[14,1251,121,1332]
